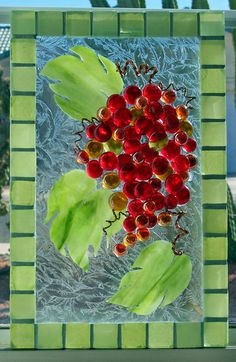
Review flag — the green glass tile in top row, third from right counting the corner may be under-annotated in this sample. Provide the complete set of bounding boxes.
[146,11,170,36]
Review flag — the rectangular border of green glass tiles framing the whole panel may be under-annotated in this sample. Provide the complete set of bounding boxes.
[11,9,228,349]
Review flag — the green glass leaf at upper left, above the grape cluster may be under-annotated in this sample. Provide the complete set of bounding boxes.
[41,46,123,120]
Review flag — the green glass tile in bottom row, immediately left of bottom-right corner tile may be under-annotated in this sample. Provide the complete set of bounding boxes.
[176,322,202,348]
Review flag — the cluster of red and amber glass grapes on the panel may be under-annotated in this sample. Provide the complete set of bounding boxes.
[77,84,197,256]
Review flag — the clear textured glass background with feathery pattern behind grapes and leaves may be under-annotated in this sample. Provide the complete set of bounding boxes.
[37,37,202,323]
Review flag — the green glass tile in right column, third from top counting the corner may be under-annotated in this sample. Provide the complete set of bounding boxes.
[201,69,226,93]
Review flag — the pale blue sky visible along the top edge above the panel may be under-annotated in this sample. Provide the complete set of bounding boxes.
[0,0,229,10]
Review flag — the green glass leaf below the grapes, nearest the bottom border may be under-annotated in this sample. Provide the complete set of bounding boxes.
[108,240,192,315]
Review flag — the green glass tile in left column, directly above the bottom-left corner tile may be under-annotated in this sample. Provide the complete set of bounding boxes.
[10,294,36,319]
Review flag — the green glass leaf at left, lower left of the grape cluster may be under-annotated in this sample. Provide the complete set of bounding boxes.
[45,170,122,270]
